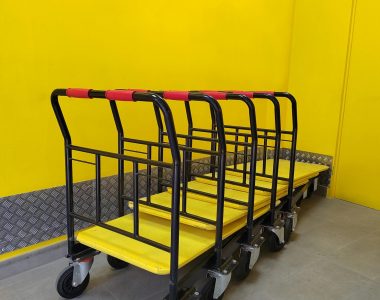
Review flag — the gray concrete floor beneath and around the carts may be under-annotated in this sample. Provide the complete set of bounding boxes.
[0,196,380,300]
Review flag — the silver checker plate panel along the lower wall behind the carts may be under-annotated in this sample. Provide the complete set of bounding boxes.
[0,149,332,254]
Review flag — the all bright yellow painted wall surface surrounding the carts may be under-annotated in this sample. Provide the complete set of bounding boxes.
[0,0,380,264]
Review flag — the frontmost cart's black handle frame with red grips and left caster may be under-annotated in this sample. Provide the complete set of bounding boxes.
[51,89,184,299]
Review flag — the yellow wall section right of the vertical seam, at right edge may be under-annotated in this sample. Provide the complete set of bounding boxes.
[336,0,380,210]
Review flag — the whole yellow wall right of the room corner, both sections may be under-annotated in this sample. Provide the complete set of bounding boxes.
[286,0,380,209]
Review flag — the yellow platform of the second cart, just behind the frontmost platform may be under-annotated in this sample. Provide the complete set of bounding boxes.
[130,192,247,230]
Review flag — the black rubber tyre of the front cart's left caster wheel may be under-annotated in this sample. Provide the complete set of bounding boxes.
[57,266,90,299]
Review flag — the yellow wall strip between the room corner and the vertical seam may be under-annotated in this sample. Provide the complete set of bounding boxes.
[287,0,351,156]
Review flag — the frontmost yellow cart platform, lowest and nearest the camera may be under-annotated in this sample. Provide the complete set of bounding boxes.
[77,207,269,275]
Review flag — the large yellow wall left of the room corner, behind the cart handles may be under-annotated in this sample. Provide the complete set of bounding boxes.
[0,0,293,196]
